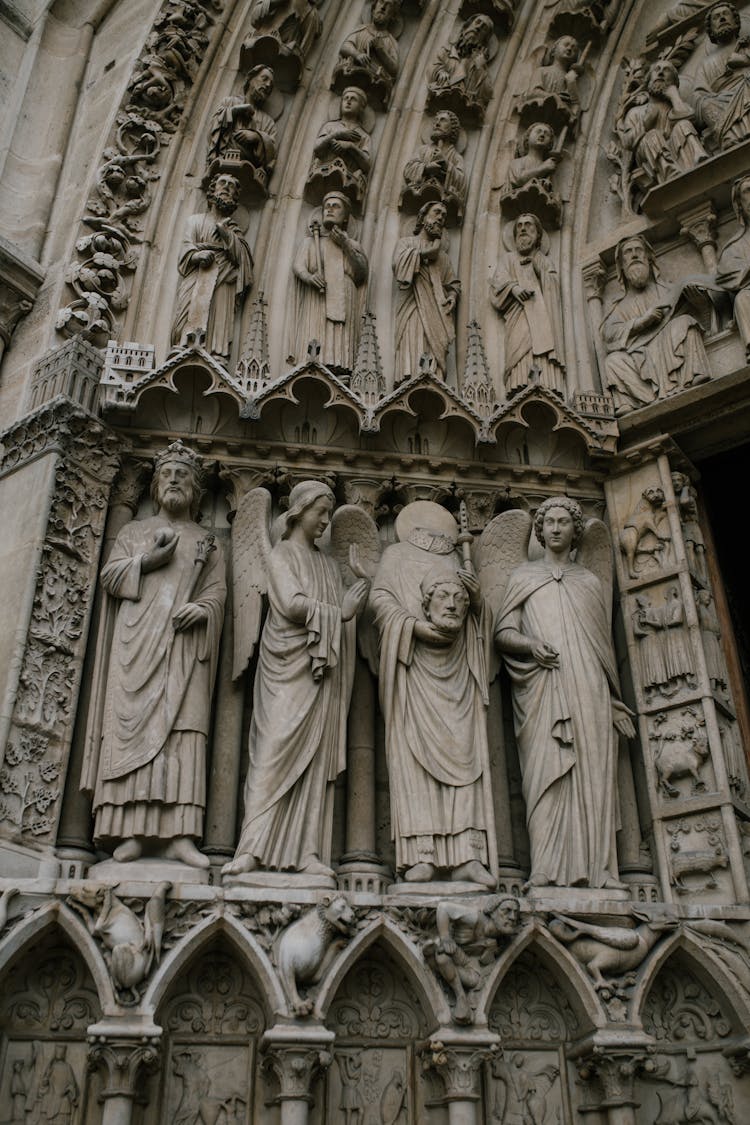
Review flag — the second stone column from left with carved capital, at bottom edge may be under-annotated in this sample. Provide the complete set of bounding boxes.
[261,1027,334,1125]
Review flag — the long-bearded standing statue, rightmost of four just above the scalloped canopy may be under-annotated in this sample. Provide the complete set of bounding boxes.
[491,215,564,398]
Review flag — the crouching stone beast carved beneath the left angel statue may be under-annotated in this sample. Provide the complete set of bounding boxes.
[275,894,354,1016]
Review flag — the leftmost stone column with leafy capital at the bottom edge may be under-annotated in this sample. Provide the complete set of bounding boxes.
[89,1028,160,1125]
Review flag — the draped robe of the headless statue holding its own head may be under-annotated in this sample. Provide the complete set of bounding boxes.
[370,532,496,871]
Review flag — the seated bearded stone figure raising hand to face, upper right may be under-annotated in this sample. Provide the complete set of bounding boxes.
[615,59,708,198]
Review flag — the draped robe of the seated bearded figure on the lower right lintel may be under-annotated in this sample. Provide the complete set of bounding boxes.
[602,278,711,413]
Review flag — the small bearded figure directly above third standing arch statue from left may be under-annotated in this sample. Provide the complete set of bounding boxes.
[399,109,467,223]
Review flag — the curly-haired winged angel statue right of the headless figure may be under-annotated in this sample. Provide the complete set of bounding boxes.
[490,496,635,889]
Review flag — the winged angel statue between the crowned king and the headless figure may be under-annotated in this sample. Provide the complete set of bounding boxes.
[224,480,378,879]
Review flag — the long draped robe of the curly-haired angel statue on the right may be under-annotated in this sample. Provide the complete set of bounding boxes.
[496,560,617,887]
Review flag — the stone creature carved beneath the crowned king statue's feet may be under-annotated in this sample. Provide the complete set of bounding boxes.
[69,882,172,1004]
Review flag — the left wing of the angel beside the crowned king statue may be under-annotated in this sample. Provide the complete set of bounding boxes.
[232,488,271,680]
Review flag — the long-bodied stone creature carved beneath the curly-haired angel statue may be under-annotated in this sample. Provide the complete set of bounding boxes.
[548,910,677,991]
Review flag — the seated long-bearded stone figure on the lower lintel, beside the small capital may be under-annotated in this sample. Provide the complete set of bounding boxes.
[602,234,711,415]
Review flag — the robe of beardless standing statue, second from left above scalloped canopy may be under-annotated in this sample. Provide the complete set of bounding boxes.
[292,231,368,371]
